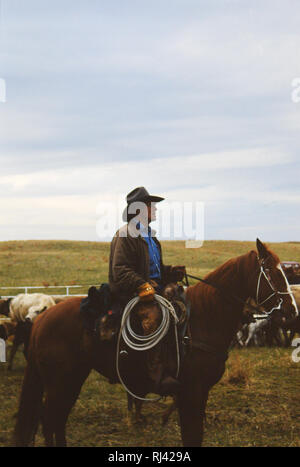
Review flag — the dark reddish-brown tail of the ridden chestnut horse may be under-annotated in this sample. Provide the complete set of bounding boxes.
[14,360,43,447]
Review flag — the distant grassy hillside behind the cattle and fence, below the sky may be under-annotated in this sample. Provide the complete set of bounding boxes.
[0,240,300,295]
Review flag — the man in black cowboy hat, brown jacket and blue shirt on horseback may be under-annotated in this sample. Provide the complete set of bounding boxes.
[109,187,185,394]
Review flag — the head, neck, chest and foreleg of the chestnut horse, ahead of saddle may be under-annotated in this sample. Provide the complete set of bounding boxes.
[178,239,299,446]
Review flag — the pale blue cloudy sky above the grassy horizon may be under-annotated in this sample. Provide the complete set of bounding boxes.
[0,0,300,245]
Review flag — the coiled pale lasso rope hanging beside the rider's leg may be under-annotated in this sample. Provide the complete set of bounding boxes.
[116,294,180,402]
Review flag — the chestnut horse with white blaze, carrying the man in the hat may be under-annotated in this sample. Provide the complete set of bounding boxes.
[15,240,298,446]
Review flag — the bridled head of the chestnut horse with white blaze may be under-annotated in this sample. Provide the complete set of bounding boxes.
[253,239,299,319]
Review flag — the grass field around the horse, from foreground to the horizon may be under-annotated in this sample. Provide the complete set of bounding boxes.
[0,241,300,447]
